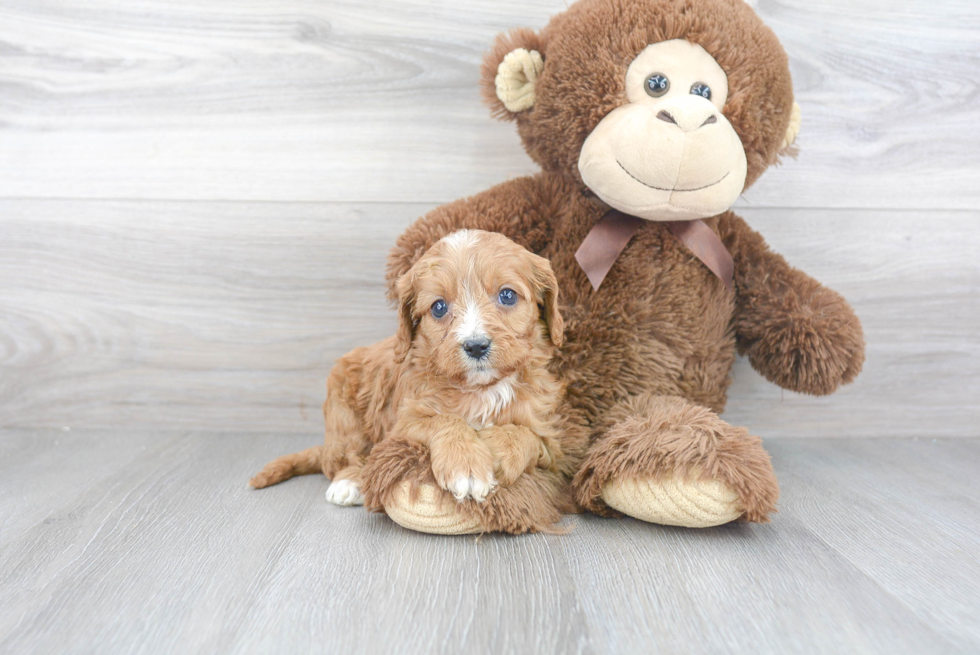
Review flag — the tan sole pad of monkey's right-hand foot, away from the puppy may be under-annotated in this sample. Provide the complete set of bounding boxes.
[602,478,742,528]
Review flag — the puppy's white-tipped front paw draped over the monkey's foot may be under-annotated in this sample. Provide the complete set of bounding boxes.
[430,439,497,503]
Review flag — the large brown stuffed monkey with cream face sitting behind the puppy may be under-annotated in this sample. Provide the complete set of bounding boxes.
[365,0,864,533]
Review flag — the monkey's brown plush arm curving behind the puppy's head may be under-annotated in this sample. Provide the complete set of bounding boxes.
[385,173,566,300]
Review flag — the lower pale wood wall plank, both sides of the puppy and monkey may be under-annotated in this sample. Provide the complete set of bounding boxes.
[0,201,980,437]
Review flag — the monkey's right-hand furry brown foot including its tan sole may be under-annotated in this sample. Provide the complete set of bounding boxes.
[573,394,779,528]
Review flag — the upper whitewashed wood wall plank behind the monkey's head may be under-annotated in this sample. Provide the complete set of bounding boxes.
[0,0,980,209]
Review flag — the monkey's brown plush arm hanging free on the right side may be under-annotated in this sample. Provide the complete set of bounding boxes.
[719,214,864,395]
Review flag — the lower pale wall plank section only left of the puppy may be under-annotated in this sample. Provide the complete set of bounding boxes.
[0,202,402,430]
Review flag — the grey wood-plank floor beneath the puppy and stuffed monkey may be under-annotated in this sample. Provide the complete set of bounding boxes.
[0,430,980,655]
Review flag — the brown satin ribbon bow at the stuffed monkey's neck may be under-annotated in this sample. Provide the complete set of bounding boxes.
[575,209,735,291]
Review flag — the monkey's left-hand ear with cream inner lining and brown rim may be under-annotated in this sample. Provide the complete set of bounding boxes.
[480,27,544,120]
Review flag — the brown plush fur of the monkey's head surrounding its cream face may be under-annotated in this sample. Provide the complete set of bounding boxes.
[481,0,793,188]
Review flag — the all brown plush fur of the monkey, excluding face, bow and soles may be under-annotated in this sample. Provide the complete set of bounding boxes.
[372,0,864,530]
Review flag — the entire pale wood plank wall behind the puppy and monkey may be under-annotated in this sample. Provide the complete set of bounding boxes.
[0,0,980,437]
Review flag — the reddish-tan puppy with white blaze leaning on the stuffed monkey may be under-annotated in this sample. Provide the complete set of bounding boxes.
[250,230,564,505]
